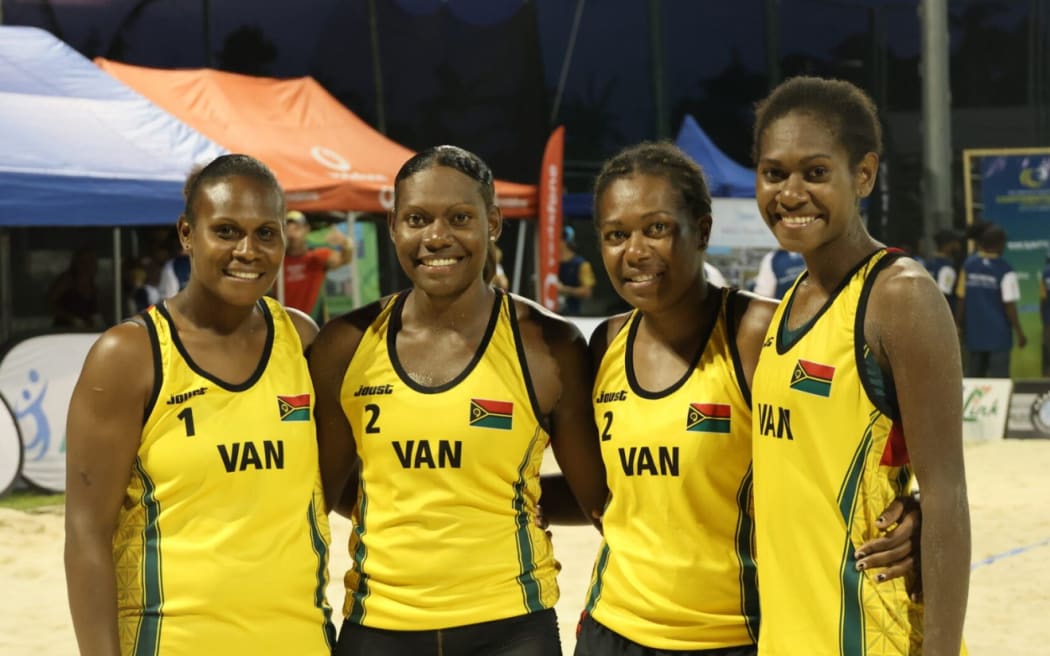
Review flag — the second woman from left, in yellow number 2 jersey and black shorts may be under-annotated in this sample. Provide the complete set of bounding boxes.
[310,146,606,656]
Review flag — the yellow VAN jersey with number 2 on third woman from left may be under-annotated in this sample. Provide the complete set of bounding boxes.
[587,290,758,651]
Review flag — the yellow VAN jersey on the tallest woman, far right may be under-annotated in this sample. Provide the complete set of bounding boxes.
[752,250,922,656]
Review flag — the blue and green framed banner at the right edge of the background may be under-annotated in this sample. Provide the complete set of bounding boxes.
[966,148,1050,379]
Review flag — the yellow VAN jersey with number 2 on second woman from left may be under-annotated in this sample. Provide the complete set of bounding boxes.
[341,292,558,631]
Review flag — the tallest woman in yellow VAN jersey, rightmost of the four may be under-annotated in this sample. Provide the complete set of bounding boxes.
[752,73,970,656]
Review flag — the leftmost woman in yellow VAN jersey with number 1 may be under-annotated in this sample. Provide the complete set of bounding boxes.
[65,155,335,656]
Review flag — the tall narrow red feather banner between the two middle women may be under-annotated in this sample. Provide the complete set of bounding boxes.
[538,126,565,312]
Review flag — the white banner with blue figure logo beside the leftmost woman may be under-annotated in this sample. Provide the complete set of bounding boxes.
[0,334,98,492]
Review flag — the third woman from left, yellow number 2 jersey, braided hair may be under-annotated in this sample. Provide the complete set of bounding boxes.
[575,143,912,656]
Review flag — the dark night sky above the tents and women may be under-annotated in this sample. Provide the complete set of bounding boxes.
[2,0,1028,182]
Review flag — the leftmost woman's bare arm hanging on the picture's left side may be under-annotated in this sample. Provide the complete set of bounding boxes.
[65,323,154,656]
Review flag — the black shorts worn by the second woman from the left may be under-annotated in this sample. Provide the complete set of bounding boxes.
[332,609,562,656]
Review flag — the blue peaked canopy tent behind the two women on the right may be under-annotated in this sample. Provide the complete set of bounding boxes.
[563,114,755,217]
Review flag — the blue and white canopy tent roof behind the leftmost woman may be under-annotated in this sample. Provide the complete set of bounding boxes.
[0,26,225,227]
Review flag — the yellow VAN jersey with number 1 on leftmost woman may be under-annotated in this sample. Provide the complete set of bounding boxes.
[113,299,335,656]
